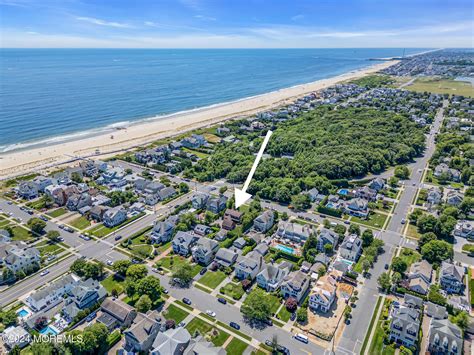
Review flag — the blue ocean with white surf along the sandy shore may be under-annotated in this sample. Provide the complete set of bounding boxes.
[0,48,426,153]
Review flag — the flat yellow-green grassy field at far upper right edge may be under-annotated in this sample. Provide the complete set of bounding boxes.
[405,78,474,97]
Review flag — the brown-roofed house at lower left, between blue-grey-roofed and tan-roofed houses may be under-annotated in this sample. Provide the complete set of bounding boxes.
[97,298,137,331]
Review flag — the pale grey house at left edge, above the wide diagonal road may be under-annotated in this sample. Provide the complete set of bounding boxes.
[2,244,40,274]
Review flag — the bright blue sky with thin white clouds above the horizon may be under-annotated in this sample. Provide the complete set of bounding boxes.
[0,0,474,48]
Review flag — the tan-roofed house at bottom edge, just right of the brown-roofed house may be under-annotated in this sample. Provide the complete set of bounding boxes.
[123,311,161,353]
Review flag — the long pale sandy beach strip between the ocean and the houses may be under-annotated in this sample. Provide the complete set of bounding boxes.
[0,61,397,179]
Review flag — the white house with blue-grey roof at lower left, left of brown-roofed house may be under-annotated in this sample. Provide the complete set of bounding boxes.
[63,279,107,321]
